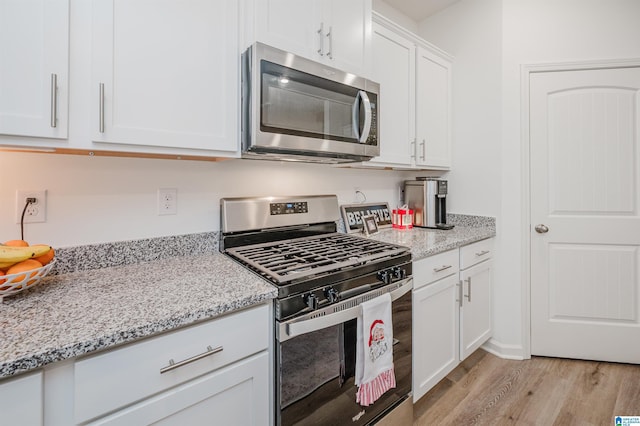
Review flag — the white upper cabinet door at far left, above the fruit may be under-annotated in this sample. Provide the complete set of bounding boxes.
[0,0,69,139]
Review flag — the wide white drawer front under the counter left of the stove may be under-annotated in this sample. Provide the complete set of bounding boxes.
[74,305,270,422]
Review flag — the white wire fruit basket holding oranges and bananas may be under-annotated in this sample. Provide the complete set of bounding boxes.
[0,240,55,302]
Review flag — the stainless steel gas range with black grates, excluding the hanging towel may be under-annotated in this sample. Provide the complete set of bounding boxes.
[220,195,413,425]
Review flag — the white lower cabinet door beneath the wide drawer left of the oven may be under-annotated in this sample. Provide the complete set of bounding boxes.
[90,352,270,426]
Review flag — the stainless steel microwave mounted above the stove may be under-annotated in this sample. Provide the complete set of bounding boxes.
[241,43,380,163]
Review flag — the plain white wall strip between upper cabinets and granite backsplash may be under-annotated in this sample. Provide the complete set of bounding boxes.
[0,152,428,247]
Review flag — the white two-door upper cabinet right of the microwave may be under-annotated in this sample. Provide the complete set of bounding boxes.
[362,14,452,170]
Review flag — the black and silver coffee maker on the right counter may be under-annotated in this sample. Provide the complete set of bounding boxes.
[404,177,453,229]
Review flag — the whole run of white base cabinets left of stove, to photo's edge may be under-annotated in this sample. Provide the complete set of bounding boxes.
[0,304,273,426]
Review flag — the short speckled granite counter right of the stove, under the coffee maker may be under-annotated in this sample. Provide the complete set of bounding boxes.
[370,215,496,261]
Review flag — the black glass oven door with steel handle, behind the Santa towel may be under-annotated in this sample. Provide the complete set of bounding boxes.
[276,278,413,426]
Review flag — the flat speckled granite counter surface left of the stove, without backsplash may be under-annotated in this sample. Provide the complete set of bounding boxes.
[0,253,277,378]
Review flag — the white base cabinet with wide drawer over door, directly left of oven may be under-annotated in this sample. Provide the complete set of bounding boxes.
[74,305,270,425]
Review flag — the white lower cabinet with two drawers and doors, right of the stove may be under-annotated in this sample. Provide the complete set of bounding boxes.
[413,239,493,402]
